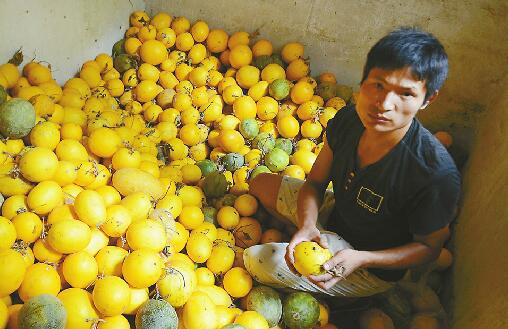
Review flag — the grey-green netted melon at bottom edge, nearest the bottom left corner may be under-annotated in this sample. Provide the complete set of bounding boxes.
[18,294,67,329]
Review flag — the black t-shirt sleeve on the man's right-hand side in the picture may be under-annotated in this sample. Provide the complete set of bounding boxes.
[407,172,460,235]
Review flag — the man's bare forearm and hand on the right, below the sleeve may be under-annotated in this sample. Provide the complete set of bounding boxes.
[309,226,450,289]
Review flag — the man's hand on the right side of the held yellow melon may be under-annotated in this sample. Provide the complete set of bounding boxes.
[309,249,365,290]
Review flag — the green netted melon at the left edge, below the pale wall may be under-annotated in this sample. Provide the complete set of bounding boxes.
[0,98,35,139]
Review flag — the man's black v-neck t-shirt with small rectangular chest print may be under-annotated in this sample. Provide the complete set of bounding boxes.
[326,105,460,281]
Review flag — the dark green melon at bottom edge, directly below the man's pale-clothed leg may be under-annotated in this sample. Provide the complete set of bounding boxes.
[282,292,319,329]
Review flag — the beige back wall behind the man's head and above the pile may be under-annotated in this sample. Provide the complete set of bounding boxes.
[146,0,508,149]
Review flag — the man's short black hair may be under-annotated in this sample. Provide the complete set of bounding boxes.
[362,27,448,100]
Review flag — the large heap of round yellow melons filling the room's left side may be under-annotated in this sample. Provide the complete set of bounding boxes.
[0,11,354,329]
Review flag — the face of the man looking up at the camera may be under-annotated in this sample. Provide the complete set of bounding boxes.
[356,68,428,133]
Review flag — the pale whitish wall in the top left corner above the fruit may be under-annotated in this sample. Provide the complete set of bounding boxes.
[0,0,145,84]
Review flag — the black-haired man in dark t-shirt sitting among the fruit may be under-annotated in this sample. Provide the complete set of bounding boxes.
[244,28,460,297]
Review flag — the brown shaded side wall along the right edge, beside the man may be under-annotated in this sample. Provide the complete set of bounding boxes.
[450,78,508,329]
